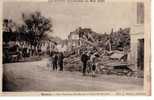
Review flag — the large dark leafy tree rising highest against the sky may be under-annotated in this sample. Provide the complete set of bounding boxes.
[19,11,52,45]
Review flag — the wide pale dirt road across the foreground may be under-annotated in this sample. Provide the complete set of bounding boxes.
[3,59,143,91]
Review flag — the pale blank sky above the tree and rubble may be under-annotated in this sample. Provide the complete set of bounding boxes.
[3,2,136,39]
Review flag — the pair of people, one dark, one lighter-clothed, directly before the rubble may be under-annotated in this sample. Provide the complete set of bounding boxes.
[81,52,99,76]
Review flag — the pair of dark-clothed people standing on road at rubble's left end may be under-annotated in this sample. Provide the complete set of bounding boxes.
[48,51,64,71]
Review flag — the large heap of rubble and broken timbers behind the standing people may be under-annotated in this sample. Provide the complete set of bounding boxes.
[64,27,130,73]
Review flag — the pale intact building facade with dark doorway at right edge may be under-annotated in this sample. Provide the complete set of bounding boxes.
[130,2,144,71]
